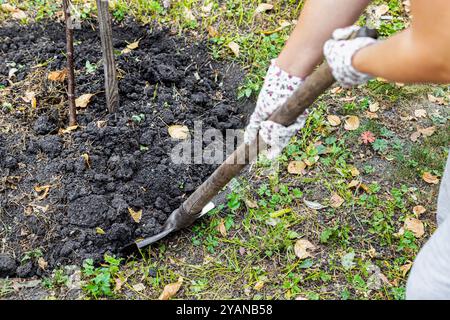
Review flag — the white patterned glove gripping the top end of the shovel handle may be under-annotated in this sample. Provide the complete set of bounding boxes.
[323,26,377,88]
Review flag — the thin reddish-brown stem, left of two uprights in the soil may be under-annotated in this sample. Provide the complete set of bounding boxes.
[63,0,77,126]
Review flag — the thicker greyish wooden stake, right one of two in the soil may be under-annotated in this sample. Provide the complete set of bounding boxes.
[97,0,119,113]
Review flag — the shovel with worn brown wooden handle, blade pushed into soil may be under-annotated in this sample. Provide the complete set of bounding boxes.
[122,28,378,255]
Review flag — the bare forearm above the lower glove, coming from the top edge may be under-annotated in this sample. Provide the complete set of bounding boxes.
[277,0,370,79]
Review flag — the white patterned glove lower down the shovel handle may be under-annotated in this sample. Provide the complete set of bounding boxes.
[244,60,308,159]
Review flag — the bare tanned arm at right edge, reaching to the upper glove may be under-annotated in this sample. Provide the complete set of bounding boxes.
[353,0,450,83]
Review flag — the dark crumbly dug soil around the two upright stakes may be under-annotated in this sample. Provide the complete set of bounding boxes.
[0,22,245,277]
